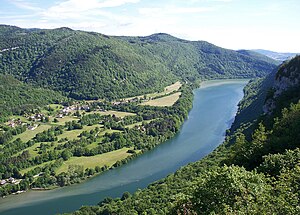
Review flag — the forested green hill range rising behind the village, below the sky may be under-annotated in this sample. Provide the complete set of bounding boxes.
[0,25,275,100]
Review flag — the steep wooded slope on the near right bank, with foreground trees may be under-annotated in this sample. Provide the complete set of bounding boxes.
[74,56,300,214]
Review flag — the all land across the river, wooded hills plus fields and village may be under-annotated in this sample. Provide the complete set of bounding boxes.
[0,25,278,203]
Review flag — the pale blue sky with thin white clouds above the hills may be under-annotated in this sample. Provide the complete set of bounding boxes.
[0,0,300,53]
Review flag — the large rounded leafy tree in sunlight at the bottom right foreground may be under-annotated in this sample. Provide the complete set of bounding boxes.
[191,166,272,214]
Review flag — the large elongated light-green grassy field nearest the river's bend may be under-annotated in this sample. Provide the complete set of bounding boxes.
[56,148,131,174]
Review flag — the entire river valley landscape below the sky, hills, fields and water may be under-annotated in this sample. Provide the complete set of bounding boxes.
[0,25,300,215]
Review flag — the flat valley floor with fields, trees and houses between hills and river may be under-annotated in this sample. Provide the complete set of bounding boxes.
[0,82,185,196]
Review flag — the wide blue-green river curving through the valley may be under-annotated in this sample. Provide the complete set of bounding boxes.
[0,80,247,215]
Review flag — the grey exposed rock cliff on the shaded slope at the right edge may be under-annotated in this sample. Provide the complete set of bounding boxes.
[263,56,300,114]
